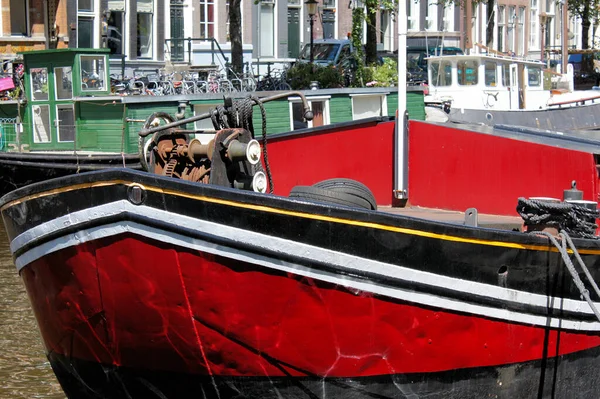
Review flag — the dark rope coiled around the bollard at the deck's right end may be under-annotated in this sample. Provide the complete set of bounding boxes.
[517,198,599,239]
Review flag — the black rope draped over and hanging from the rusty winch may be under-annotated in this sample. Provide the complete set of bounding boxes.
[210,95,273,194]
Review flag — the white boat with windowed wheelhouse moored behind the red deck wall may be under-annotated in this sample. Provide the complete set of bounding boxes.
[425,54,600,130]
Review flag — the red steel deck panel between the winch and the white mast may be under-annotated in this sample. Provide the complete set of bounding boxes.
[267,121,395,205]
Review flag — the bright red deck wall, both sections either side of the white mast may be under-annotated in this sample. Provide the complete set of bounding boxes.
[268,121,598,216]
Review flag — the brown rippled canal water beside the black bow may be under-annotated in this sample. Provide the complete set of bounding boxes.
[0,227,65,399]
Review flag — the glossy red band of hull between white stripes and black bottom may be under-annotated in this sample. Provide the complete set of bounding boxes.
[21,235,600,377]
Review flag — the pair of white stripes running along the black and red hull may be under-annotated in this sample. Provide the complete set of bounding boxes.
[11,200,600,331]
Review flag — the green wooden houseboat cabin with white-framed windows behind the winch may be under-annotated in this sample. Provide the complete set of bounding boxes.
[0,48,425,153]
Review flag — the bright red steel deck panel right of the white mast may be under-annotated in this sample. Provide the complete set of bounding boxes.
[408,121,598,216]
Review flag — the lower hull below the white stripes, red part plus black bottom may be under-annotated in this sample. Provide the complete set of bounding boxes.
[21,234,600,398]
